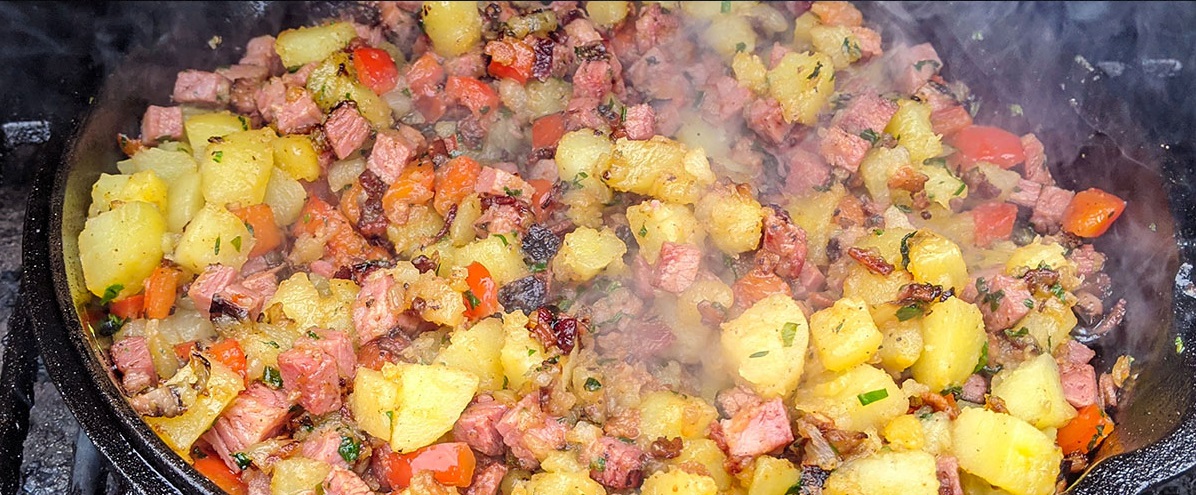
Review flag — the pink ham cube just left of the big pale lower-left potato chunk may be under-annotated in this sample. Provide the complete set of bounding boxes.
[279,342,341,415]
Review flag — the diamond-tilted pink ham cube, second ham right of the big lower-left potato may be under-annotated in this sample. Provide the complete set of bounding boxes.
[495,393,567,469]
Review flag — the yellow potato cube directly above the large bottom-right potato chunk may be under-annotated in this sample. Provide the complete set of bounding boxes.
[993,354,1075,429]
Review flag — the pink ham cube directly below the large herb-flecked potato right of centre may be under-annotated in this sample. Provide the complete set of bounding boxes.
[719,398,793,457]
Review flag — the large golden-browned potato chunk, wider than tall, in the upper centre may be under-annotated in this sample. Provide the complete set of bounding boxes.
[603,136,714,204]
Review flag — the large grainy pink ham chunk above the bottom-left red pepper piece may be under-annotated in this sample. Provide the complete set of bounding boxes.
[203,381,291,471]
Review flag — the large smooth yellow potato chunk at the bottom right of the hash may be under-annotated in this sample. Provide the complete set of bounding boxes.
[951,408,1063,495]
